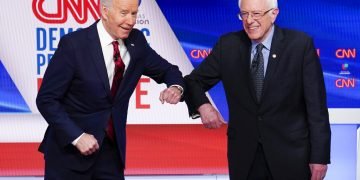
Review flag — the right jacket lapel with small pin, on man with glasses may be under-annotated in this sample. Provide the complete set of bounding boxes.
[262,26,284,99]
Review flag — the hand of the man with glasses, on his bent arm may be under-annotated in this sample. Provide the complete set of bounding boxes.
[198,103,226,129]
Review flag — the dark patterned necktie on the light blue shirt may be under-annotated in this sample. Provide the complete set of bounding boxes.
[251,44,264,103]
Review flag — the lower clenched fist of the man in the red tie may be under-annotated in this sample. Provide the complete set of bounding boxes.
[75,133,99,156]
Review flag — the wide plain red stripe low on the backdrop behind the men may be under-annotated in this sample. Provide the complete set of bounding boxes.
[0,125,228,176]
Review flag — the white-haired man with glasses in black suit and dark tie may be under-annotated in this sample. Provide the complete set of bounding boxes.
[185,0,331,180]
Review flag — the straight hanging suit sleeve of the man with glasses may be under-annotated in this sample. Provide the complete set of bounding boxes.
[303,39,331,164]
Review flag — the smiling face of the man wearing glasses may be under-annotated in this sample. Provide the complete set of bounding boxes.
[240,0,279,43]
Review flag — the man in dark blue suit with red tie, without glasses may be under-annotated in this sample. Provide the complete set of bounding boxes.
[36,0,184,179]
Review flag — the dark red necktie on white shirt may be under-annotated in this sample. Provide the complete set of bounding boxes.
[106,41,125,142]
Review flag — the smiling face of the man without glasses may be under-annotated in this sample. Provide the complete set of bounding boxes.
[101,0,138,39]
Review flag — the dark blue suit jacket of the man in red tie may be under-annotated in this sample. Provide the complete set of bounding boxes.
[36,22,184,170]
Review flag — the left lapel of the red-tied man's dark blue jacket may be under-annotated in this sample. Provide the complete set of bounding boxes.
[88,21,111,100]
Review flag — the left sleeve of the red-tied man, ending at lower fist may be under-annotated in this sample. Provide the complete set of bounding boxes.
[36,36,83,147]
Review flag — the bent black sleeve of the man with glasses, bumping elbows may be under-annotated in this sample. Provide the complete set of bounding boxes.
[185,40,222,117]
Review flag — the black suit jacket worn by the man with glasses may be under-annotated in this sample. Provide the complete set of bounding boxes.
[185,26,330,180]
